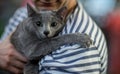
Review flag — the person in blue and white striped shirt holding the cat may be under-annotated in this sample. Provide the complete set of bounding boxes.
[0,0,108,74]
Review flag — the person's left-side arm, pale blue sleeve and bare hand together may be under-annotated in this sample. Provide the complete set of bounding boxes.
[0,8,27,74]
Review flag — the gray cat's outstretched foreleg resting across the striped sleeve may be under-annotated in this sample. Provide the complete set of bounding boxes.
[29,33,92,60]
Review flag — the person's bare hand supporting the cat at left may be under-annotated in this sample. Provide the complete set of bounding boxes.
[0,37,27,74]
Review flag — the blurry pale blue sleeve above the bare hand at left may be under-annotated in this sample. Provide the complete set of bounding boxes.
[1,7,27,41]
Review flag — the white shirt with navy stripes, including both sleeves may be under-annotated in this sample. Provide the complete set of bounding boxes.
[2,2,108,74]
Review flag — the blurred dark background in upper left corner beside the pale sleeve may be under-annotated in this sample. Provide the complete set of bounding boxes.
[0,0,22,36]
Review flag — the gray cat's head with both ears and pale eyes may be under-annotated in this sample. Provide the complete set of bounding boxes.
[27,5,67,38]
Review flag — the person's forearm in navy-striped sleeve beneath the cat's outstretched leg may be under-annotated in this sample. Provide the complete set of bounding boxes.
[40,45,101,74]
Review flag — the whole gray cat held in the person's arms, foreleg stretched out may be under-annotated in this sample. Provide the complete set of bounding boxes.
[11,5,92,74]
